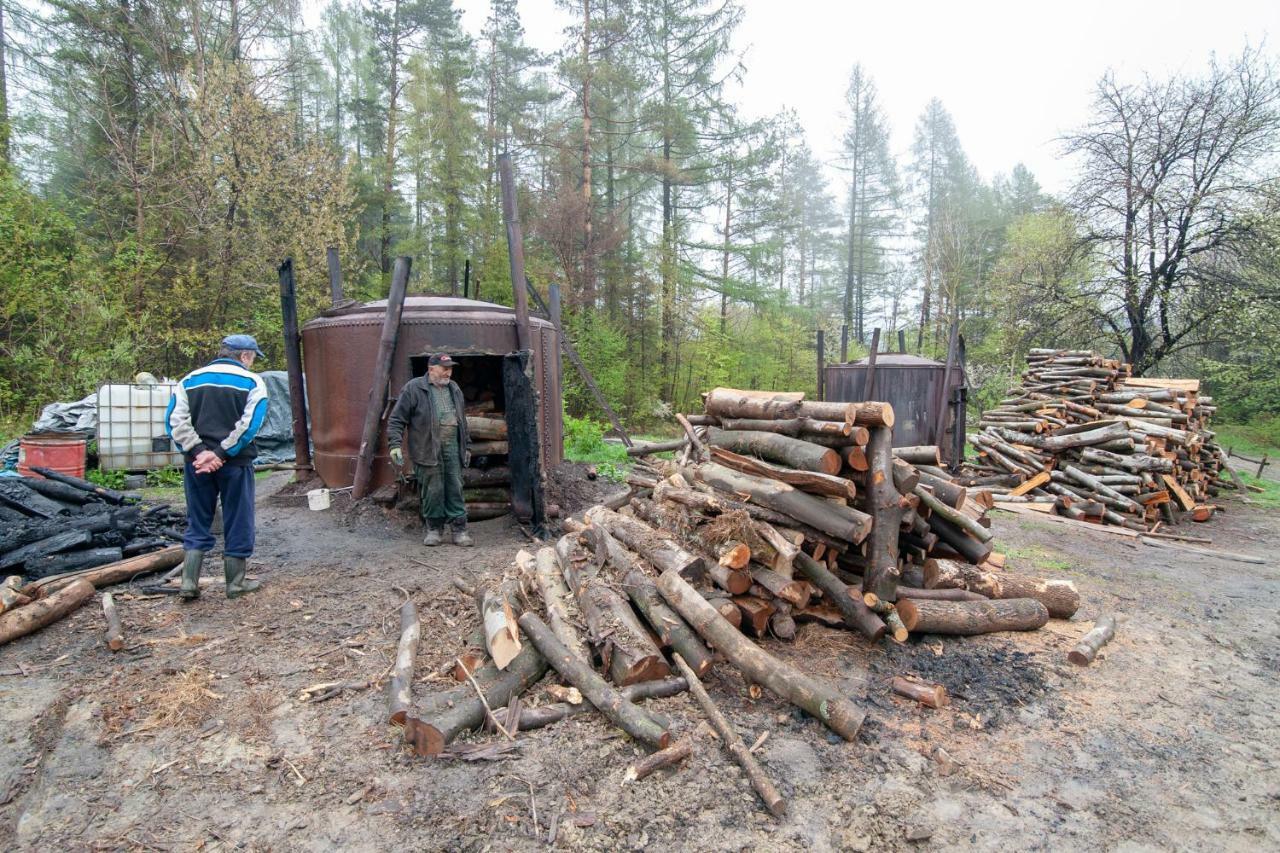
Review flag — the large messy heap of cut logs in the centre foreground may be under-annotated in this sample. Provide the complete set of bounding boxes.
[390,389,1079,778]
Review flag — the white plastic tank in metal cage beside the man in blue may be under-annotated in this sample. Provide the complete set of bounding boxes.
[97,383,182,471]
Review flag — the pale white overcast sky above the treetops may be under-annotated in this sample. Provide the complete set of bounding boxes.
[460,0,1280,192]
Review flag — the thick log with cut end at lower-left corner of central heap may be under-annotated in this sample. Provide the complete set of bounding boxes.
[404,643,547,756]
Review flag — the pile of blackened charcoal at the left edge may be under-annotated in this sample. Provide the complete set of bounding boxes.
[0,467,187,580]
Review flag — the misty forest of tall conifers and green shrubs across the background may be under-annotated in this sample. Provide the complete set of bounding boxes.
[0,0,1280,429]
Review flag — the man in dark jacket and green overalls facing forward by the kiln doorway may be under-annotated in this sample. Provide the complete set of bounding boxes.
[387,352,474,547]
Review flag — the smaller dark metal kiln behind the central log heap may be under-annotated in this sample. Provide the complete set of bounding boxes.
[823,352,968,462]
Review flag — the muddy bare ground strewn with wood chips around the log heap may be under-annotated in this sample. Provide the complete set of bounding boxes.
[0,475,1280,850]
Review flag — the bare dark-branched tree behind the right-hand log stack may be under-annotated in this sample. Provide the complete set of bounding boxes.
[1065,50,1280,374]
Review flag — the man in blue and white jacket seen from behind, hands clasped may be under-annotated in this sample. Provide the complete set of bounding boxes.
[165,334,266,601]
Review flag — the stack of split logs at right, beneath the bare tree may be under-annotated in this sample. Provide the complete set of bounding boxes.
[964,350,1228,532]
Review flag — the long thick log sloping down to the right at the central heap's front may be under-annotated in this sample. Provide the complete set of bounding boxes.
[658,571,867,740]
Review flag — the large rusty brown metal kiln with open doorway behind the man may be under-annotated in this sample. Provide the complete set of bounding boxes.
[302,296,564,488]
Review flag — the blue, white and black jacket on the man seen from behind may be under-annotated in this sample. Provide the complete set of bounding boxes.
[165,359,266,465]
